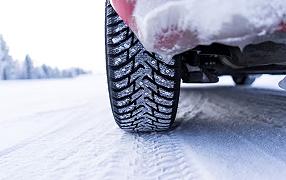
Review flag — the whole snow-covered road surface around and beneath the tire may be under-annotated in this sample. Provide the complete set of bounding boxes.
[0,75,286,180]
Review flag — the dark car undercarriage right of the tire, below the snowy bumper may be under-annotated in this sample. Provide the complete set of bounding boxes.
[174,38,286,83]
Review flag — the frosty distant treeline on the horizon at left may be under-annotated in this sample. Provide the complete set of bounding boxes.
[0,35,89,80]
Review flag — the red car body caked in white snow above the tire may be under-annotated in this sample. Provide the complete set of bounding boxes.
[111,0,286,56]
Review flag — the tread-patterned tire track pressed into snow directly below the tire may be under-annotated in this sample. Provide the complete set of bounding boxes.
[126,132,204,179]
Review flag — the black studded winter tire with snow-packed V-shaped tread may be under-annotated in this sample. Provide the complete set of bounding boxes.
[105,1,180,132]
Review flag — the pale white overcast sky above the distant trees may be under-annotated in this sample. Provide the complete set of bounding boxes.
[0,0,105,72]
